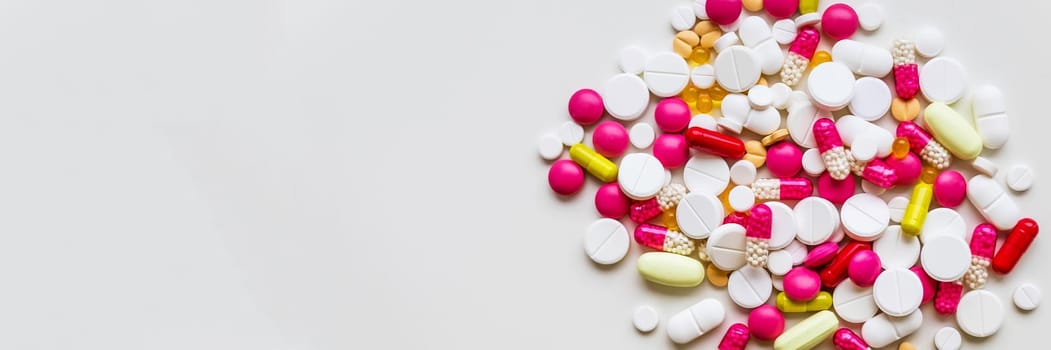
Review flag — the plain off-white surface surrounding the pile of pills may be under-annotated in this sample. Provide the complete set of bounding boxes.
[0,0,1051,349]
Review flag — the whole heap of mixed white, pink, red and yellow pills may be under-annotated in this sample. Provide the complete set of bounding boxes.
[539,0,1040,350]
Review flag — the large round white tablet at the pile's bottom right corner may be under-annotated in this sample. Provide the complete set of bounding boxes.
[956,289,1006,337]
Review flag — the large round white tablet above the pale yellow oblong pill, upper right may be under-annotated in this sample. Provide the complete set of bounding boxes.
[920,57,967,104]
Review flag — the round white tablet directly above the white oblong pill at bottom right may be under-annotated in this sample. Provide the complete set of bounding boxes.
[872,269,923,317]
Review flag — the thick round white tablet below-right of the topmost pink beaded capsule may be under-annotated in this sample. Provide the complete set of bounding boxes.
[806,61,854,110]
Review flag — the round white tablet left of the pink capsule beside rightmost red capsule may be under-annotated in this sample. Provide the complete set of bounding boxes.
[920,235,971,282]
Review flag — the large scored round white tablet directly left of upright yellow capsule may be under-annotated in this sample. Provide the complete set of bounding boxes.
[840,193,890,242]
